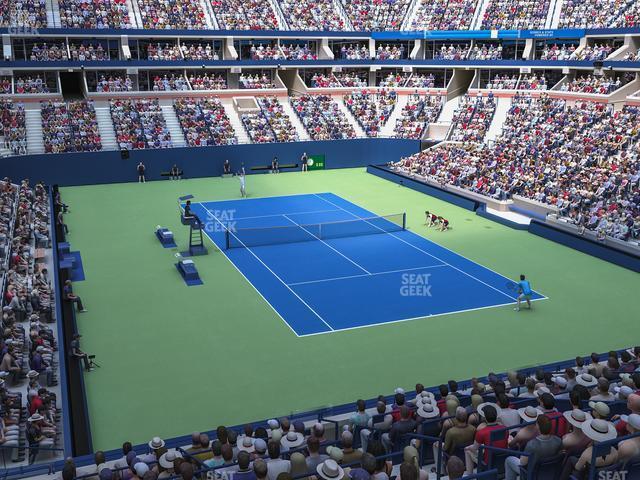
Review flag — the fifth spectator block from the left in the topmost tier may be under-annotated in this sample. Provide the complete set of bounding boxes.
[278,0,345,31]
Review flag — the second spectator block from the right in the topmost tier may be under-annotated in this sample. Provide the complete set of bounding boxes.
[481,0,550,30]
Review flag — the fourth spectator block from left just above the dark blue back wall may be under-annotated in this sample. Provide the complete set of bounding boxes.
[173,97,238,147]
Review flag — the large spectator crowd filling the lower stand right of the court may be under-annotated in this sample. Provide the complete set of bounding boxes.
[402,94,640,240]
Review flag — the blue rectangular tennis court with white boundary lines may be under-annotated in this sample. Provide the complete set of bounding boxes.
[192,193,545,336]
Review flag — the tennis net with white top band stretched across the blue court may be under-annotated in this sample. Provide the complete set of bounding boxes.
[225,213,406,248]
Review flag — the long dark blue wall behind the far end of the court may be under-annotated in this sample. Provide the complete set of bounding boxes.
[0,138,420,186]
